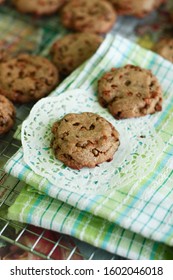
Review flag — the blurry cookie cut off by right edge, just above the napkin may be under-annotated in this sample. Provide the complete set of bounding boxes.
[154,38,173,63]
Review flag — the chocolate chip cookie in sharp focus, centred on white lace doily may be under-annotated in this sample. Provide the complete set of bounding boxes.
[52,112,120,169]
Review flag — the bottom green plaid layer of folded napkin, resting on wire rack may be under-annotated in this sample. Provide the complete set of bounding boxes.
[9,186,173,260]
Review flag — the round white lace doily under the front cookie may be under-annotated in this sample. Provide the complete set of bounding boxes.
[22,89,162,194]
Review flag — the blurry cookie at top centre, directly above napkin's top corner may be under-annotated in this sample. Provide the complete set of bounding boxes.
[61,0,116,34]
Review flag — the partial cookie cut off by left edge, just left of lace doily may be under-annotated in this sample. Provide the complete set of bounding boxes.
[0,95,16,135]
